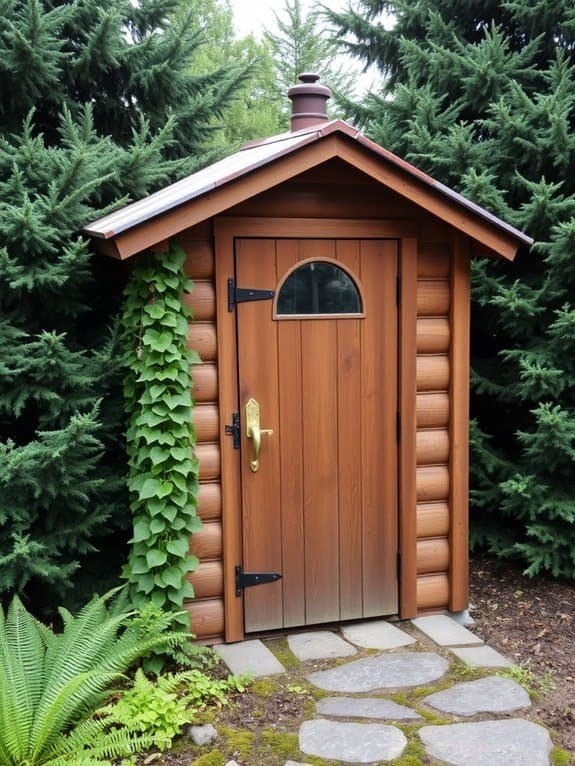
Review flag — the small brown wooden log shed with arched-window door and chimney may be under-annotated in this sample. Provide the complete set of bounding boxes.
[85,75,531,641]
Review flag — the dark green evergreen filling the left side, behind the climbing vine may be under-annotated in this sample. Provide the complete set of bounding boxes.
[0,0,251,604]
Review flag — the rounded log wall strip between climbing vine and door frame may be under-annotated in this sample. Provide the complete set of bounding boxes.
[178,225,224,643]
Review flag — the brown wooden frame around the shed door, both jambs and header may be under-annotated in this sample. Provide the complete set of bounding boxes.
[213,217,417,642]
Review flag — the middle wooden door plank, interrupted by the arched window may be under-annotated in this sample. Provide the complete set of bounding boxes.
[300,240,339,624]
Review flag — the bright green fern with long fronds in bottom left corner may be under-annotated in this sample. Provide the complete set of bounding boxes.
[0,589,190,766]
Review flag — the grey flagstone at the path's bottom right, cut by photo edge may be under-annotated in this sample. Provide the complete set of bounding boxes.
[419,718,553,766]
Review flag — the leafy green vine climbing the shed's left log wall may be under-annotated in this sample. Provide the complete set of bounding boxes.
[123,244,201,627]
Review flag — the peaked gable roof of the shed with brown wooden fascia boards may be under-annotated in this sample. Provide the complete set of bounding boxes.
[83,120,533,260]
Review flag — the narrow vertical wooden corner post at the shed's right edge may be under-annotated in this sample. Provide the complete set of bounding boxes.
[449,233,470,612]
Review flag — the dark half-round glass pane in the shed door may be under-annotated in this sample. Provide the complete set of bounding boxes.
[277,261,362,315]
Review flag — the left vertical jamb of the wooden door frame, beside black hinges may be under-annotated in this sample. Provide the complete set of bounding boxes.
[215,233,244,641]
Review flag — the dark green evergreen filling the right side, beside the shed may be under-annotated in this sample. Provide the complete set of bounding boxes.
[332,0,575,577]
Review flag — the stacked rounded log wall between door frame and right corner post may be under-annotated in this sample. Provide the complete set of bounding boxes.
[416,240,451,612]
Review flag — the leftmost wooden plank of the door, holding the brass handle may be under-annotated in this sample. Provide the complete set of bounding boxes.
[236,239,283,632]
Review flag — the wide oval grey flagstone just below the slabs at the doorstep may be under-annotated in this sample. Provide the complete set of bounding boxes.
[307,652,449,693]
